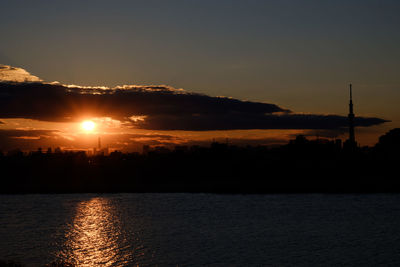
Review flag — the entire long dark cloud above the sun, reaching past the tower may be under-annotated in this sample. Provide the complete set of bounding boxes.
[0,82,385,131]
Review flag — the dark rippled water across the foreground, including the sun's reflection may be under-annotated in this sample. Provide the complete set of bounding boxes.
[0,194,400,266]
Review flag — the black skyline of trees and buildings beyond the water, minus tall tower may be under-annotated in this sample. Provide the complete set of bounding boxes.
[0,128,400,193]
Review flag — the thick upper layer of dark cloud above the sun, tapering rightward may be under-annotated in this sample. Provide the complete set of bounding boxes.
[0,82,288,123]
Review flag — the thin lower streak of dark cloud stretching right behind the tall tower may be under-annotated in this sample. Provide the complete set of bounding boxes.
[135,112,385,131]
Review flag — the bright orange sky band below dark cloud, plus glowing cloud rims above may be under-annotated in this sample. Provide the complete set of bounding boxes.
[0,65,391,151]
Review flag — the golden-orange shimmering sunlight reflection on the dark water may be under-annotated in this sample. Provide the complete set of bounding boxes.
[59,198,133,266]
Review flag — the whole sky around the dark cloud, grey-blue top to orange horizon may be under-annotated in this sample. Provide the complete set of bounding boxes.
[0,0,400,152]
